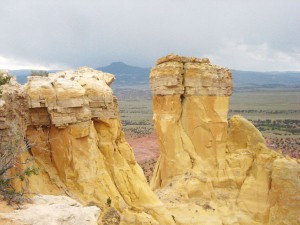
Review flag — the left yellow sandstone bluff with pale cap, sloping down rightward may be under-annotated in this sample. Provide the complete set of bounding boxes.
[1,68,174,224]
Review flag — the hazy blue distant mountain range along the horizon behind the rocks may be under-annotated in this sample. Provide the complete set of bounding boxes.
[10,62,300,90]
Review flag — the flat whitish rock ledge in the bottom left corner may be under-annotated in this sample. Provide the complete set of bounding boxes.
[0,195,100,225]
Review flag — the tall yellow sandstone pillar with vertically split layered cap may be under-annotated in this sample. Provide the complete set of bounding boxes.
[150,55,233,188]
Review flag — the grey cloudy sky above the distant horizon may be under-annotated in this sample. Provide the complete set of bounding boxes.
[0,0,300,71]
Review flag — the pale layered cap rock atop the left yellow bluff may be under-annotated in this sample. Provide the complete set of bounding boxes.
[26,68,119,127]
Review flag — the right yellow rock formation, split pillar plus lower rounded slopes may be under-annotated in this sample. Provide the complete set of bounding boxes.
[150,55,300,225]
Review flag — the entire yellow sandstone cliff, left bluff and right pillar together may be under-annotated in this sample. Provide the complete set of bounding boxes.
[0,55,300,225]
